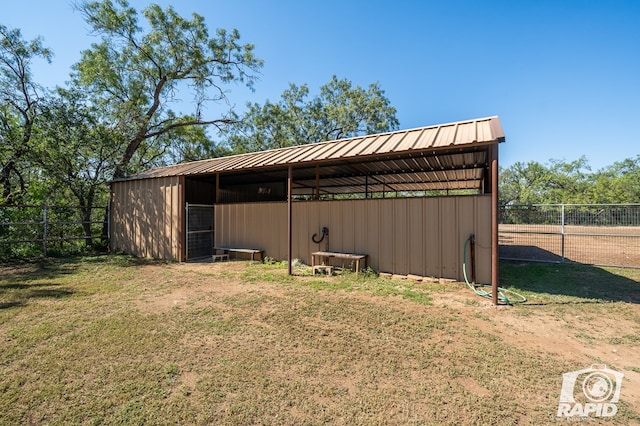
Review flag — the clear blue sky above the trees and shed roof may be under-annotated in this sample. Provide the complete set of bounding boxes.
[0,0,640,170]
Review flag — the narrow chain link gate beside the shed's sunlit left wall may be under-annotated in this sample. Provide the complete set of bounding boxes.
[185,203,214,260]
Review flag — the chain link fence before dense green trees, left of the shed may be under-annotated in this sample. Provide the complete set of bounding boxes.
[0,205,105,259]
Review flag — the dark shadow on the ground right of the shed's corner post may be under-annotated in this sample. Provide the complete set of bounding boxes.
[500,261,640,305]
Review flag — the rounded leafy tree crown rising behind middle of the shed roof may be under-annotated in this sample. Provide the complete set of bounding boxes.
[226,76,398,153]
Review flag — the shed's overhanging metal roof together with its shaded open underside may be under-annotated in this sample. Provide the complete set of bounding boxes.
[115,116,505,201]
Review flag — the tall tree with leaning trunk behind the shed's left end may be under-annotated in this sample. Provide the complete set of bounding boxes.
[72,0,262,178]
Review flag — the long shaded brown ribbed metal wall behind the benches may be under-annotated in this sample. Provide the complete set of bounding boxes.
[215,195,491,283]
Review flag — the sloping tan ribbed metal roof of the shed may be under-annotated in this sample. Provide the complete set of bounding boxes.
[122,116,505,183]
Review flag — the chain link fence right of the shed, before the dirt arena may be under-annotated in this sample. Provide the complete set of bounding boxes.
[499,204,640,268]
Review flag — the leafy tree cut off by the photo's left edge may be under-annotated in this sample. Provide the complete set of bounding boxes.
[0,25,52,205]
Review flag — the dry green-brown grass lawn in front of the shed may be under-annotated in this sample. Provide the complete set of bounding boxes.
[0,256,640,425]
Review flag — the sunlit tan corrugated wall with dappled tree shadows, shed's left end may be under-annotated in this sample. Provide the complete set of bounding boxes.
[110,176,184,260]
